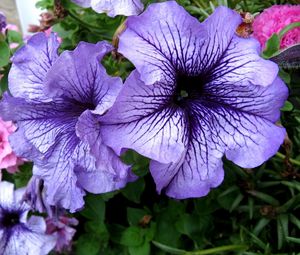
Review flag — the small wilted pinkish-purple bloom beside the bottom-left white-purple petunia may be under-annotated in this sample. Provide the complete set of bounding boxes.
[46,216,78,252]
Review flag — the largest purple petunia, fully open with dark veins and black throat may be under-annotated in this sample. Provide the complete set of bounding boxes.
[101,1,288,199]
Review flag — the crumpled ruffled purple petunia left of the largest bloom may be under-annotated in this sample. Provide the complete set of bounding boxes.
[0,33,135,212]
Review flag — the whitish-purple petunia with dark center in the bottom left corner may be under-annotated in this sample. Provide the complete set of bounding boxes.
[0,181,56,255]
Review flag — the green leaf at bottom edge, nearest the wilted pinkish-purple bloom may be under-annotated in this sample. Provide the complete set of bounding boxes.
[76,234,101,255]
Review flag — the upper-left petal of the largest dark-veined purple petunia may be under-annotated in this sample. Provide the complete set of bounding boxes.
[119,1,207,85]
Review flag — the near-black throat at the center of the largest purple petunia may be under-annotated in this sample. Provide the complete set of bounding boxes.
[173,73,206,106]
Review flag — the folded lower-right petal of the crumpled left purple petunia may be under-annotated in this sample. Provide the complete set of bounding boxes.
[75,110,136,193]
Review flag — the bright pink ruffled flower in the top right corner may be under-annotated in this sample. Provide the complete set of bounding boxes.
[253,5,300,49]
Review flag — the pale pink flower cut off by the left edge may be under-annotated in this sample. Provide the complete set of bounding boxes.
[0,118,23,173]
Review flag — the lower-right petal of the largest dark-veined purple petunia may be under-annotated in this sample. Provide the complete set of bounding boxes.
[191,97,285,168]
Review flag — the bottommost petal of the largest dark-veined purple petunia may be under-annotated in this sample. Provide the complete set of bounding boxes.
[150,141,224,199]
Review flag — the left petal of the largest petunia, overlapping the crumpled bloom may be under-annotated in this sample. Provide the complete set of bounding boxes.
[100,71,185,163]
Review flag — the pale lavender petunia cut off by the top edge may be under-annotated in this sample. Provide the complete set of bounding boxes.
[72,0,144,17]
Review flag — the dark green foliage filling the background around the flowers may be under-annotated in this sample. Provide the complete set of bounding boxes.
[0,0,300,255]
